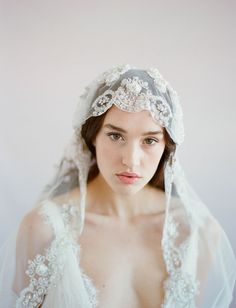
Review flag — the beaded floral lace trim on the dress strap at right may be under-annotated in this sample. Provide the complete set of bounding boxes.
[162,216,198,308]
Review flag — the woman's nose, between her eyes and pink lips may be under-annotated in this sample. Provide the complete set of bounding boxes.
[122,143,142,170]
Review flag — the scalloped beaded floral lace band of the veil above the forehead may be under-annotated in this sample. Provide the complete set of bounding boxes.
[92,77,172,127]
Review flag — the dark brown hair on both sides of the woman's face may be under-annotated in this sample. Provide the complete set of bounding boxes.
[81,112,176,190]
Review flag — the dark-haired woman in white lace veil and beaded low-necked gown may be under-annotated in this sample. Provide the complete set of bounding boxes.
[0,65,236,308]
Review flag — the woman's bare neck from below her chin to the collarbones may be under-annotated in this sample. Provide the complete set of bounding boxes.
[87,175,165,221]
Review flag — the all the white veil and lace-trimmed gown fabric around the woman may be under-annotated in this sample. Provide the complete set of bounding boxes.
[0,65,236,308]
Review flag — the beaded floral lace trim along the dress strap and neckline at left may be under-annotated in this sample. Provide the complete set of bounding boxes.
[16,204,98,308]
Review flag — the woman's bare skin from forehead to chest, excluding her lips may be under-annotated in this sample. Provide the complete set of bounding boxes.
[79,107,167,308]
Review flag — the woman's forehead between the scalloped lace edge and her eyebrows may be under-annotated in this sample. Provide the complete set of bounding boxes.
[103,105,163,131]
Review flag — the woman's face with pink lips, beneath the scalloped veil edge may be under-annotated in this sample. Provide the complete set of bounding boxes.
[94,106,165,195]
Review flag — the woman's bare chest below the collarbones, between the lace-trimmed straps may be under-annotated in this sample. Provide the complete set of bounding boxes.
[76,214,167,308]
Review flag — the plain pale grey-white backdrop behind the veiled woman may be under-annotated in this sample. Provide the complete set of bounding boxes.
[0,0,236,305]
